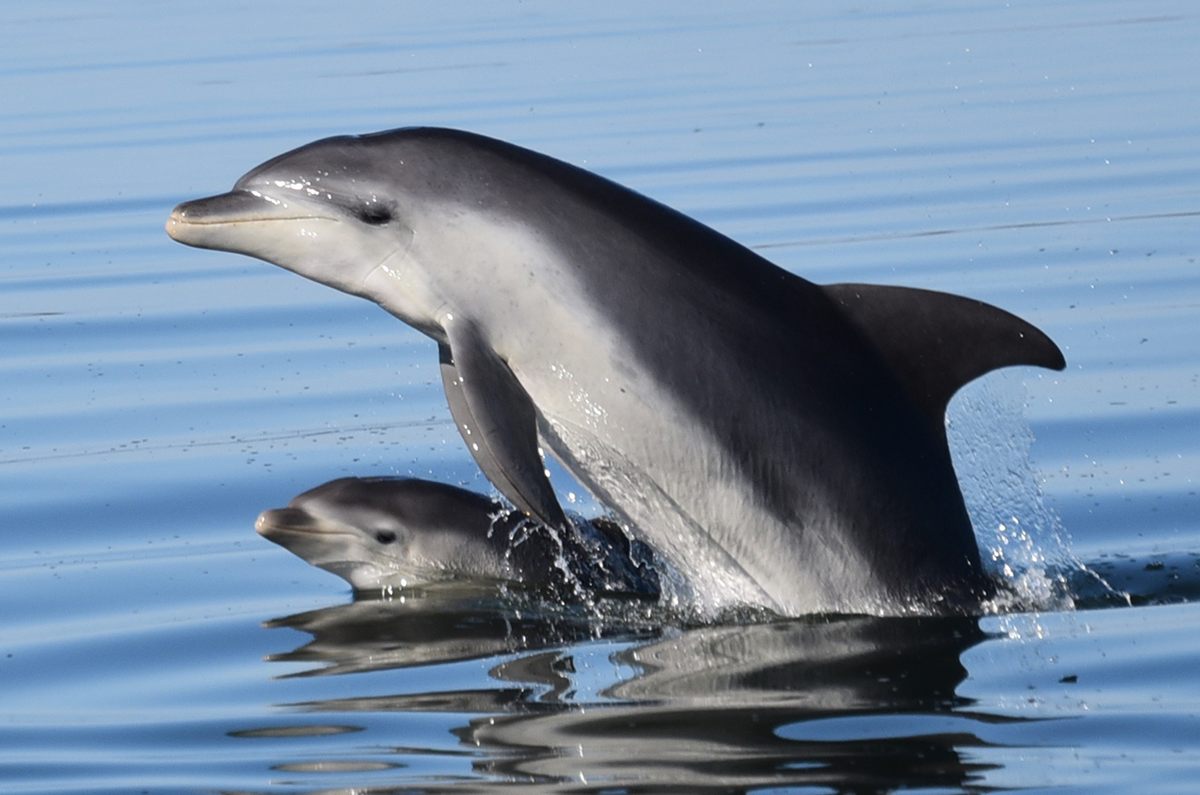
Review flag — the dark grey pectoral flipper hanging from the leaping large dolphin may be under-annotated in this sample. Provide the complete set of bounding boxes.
[438,333,566,527]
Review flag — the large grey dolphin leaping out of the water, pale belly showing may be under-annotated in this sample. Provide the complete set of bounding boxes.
[167,127,1064,615]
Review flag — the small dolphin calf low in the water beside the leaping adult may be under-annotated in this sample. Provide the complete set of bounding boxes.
[254,477,659,598]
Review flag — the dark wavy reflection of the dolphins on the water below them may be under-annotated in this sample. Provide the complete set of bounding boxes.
[258,592,1010,793]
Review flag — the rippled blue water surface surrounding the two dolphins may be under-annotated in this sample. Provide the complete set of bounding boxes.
[0,0,1200,794]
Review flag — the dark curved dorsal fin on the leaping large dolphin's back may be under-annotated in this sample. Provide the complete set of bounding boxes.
[823,285,1067,425]
